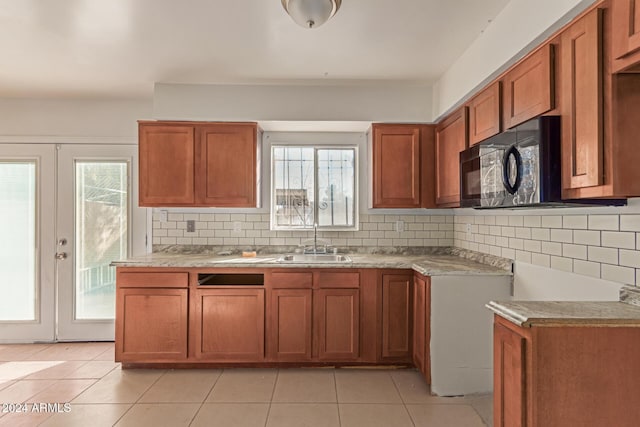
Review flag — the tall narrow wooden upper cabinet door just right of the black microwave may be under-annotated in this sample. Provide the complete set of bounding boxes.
[560,9,604,189]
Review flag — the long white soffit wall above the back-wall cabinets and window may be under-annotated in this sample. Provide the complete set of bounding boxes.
[153,84,432,123]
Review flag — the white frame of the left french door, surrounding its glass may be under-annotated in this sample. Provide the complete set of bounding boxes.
[0,143,56,343]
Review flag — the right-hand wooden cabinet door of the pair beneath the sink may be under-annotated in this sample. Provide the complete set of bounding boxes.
[313,289,360,360]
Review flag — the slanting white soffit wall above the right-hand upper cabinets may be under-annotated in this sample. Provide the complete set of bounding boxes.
[433,0,595,121]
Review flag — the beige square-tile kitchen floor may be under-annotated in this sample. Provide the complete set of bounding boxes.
[0,343,492,427]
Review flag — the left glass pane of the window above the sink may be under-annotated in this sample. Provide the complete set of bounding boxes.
[272,147,315,228]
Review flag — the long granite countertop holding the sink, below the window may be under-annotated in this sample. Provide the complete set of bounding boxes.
[111,253,512,276]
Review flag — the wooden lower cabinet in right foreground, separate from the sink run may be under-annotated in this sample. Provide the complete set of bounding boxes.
[493,315,640,427]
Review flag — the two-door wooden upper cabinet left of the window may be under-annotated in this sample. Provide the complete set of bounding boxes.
[138,122,258,207]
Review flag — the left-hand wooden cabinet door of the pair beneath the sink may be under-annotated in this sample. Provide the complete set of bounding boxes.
[268,289,312,362]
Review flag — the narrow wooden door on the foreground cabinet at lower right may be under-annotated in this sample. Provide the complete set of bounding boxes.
[493,323,528,427]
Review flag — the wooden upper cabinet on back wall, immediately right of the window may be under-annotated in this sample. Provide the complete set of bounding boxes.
[371,123,433,208]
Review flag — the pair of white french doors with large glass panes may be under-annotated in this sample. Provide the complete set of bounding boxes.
[0,144,146,342]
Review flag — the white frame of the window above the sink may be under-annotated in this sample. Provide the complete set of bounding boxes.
[269,141,360,232]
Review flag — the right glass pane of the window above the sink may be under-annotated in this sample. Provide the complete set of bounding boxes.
[318,149,355,226]
